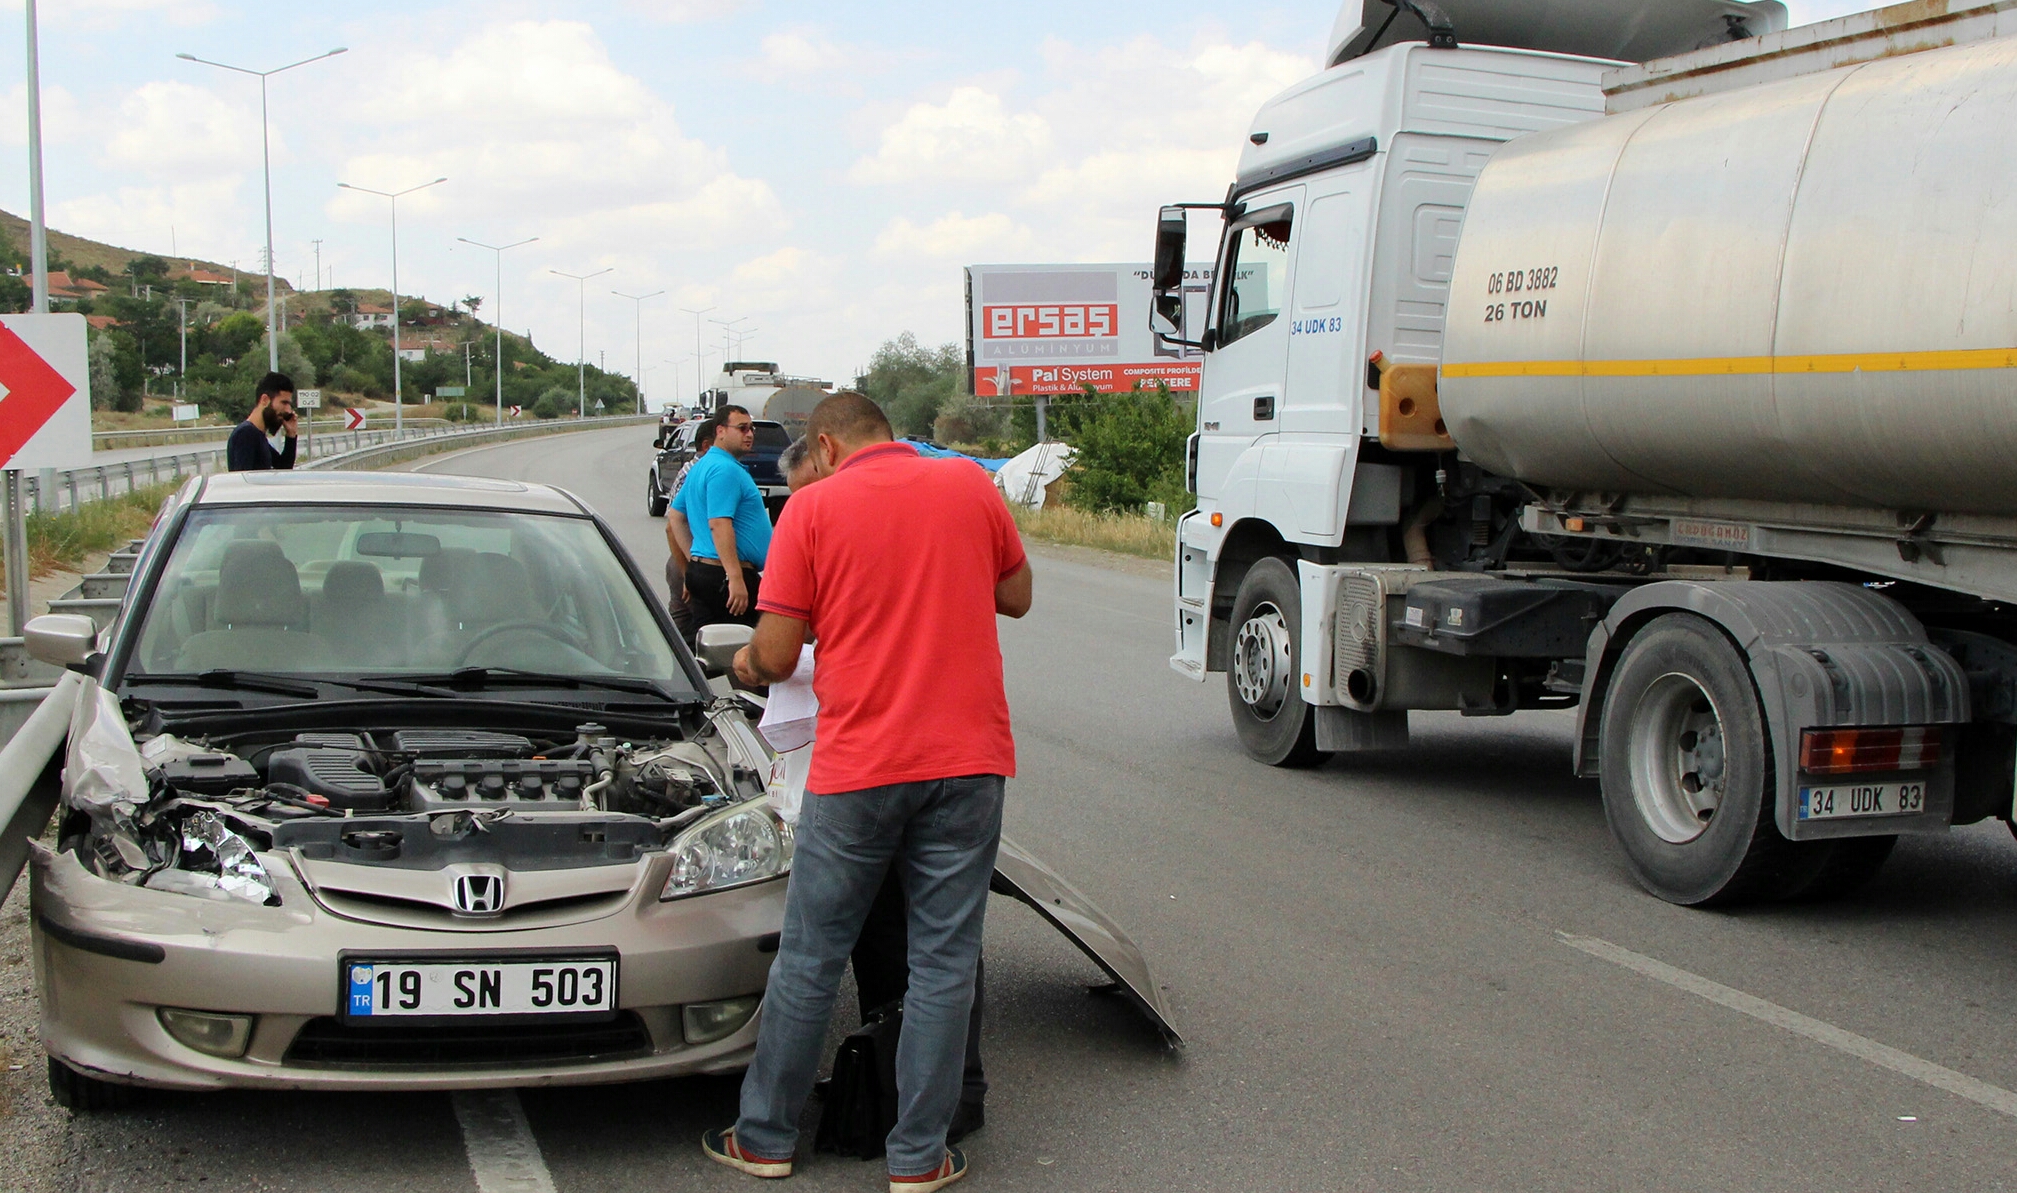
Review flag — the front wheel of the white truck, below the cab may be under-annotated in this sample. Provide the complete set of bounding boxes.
[1226,559,1325,767]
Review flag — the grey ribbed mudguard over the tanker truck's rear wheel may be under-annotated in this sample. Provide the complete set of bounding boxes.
[1575,579,1971,842]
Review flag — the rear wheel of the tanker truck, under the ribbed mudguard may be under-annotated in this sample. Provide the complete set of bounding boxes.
[1597,614,1833,906]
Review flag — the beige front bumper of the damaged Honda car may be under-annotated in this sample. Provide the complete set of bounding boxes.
[30,846,785,1090]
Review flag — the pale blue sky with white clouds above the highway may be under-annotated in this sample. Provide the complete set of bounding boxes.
[0,0,1870,400]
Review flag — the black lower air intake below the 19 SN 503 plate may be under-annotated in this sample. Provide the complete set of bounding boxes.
[286,1011,651,1070]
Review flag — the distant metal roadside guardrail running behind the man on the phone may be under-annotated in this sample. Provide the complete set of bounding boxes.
[22,414,658,513]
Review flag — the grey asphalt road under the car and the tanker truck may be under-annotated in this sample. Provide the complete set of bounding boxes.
[0,428,2017,1193]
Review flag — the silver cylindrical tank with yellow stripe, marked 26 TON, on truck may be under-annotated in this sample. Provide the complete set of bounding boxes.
[1440,36,2017,515]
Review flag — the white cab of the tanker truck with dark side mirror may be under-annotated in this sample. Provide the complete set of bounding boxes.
[1158,42,1616,761]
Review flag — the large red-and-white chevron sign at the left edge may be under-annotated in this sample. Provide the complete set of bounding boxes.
[0,313,91,468]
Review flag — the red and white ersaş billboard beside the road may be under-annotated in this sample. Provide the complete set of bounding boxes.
[966,264,1212,398]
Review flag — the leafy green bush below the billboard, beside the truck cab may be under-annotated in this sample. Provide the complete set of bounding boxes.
[1065,386,1190,511]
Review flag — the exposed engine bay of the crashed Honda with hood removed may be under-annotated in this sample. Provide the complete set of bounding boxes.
[63,719,789,906]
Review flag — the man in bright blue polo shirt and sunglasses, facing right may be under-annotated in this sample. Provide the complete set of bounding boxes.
[672,406,770,632]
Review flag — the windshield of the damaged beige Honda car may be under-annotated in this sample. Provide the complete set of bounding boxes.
[127,505,692,692]
